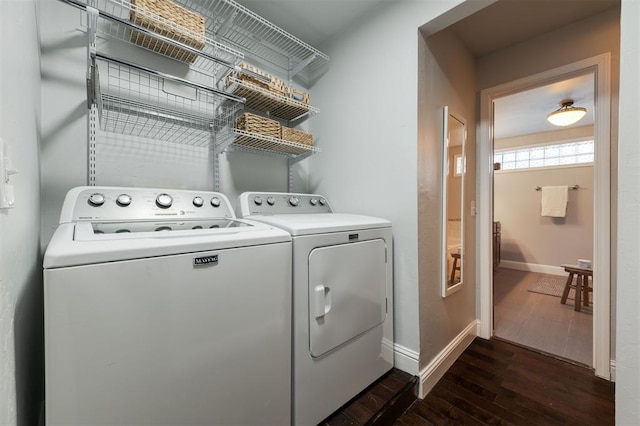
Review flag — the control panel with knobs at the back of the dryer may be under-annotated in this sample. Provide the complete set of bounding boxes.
[238,192,333,217]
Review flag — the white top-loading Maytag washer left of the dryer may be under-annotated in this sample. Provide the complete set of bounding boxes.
[44,187,291,426]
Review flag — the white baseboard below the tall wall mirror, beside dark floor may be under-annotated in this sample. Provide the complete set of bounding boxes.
[418,320,478,398]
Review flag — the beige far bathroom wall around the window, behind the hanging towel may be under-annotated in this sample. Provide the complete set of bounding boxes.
[493,126,594,267]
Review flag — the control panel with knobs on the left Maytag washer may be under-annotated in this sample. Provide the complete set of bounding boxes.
[60,186,235,223]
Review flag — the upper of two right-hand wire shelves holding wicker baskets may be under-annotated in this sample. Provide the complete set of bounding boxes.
[227,75,320,121]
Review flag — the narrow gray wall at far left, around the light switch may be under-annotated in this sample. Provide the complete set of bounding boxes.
[0,0,44,425]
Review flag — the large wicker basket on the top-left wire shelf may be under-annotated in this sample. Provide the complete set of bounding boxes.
[129,0,205,63]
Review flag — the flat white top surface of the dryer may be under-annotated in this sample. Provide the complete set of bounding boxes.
[241,213,391,236]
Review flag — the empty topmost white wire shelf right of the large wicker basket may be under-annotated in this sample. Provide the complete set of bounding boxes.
[177,0,329,82]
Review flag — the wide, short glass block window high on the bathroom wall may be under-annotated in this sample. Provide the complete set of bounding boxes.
[493,140,594,170]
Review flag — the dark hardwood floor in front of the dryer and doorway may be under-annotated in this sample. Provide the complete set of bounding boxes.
[323,338,615,426]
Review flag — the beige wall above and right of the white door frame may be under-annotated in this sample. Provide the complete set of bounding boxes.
[477,4,620,359]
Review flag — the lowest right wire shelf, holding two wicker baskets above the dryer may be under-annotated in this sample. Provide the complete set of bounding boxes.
[216,127,321,158]
